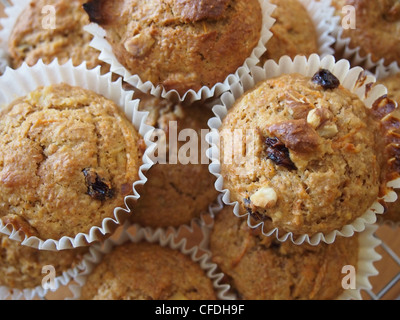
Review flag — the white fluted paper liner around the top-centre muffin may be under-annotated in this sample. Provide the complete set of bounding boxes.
[84,0,275,103]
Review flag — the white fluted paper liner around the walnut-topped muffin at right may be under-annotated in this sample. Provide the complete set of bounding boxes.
[206,54,400,245]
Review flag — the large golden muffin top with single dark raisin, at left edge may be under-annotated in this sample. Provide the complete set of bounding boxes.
[0,84,144,239]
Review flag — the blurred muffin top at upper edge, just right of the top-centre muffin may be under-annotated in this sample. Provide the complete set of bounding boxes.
[260,0,318,64]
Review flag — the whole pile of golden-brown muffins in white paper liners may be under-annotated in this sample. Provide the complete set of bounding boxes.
[0,0,400,300]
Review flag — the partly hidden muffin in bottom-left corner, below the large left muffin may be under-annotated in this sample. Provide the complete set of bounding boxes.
[0,235,88,290]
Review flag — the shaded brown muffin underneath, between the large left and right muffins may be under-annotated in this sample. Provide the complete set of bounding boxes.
[131,93,218,228]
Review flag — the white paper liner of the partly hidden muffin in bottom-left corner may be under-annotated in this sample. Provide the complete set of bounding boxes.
[0,242,99,300]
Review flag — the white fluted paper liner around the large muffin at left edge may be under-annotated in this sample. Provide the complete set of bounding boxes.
[0,60,156,250]
